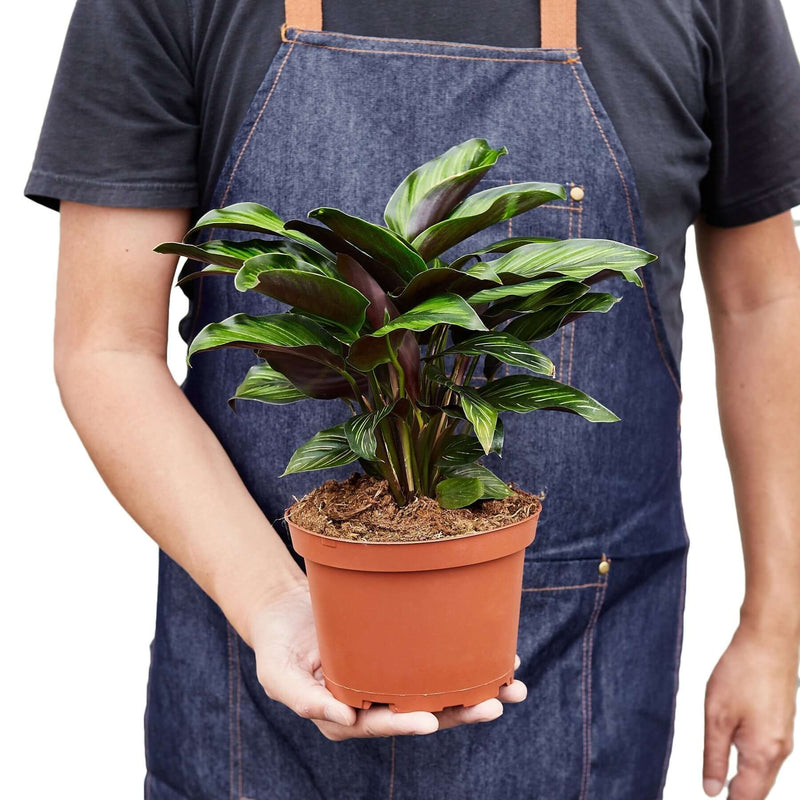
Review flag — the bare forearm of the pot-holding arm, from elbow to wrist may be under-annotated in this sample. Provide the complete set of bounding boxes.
[56,350,304,642]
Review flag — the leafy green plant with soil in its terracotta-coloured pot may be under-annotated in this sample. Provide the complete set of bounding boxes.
[156,139,655,711]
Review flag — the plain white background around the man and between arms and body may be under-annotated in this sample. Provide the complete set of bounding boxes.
[0,0,800,800]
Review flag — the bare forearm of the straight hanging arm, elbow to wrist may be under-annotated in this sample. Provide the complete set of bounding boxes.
[711,291,800,643]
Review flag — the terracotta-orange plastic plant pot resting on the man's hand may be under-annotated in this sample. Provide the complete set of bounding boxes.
[286,505,541,711]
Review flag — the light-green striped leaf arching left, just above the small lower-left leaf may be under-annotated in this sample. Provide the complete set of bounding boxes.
[186,314,342,364]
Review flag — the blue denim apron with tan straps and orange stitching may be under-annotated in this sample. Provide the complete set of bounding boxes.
[145,0,688,800]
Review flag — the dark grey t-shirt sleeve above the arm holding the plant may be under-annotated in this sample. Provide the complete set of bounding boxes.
[24,0,199,209]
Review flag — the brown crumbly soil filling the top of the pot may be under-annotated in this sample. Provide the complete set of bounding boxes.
[288,473,542,542]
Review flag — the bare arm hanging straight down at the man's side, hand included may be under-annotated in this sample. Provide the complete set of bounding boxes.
[696,212,800,800]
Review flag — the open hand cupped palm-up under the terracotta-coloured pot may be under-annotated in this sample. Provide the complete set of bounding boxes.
[250,584,528,741]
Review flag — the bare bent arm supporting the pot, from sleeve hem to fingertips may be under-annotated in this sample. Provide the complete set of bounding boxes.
[54,202,526,738]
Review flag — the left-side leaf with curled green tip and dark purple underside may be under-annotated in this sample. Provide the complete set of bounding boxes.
[234,253,369,333]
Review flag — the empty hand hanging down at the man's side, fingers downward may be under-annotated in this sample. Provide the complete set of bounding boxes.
[703,625,798,800]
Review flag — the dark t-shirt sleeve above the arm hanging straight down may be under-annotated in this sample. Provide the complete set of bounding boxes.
[700,0,800,227]
